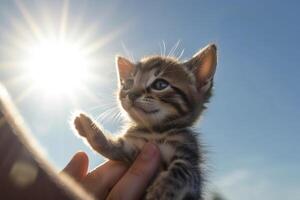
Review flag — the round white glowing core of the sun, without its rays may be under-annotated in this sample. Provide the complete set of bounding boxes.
[25,39,88,96]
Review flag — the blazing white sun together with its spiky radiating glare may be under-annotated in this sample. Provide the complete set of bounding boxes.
[0,0,124,101]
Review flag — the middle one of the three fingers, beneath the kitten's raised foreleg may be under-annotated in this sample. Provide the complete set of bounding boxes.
[82,161,128,199]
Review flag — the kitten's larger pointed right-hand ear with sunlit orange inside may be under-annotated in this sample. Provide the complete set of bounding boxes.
[186,44,217,92]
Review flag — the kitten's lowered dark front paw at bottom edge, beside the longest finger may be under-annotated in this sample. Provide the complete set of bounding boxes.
[145,173,176,200]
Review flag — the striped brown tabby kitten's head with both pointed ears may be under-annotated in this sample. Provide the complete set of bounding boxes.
[116,44,217,130]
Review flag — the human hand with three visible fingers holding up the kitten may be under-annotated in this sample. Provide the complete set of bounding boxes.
[63,143,160,200]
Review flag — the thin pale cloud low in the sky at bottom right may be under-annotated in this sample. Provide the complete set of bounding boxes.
[216,169,300,200]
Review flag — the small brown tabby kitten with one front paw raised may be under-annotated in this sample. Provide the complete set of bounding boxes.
[75,44,217,200]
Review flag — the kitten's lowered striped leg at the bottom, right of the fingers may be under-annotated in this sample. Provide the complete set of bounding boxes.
[145,147,202,200]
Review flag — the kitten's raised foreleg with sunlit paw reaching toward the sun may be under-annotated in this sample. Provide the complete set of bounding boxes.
[74,114,138,163]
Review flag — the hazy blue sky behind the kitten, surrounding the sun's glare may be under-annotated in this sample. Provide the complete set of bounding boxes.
[0,0,300,200]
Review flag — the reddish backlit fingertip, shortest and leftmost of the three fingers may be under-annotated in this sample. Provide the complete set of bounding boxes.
[62,152,89,181]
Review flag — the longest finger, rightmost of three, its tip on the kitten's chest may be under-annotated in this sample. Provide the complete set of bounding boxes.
[108,143,160,200]
